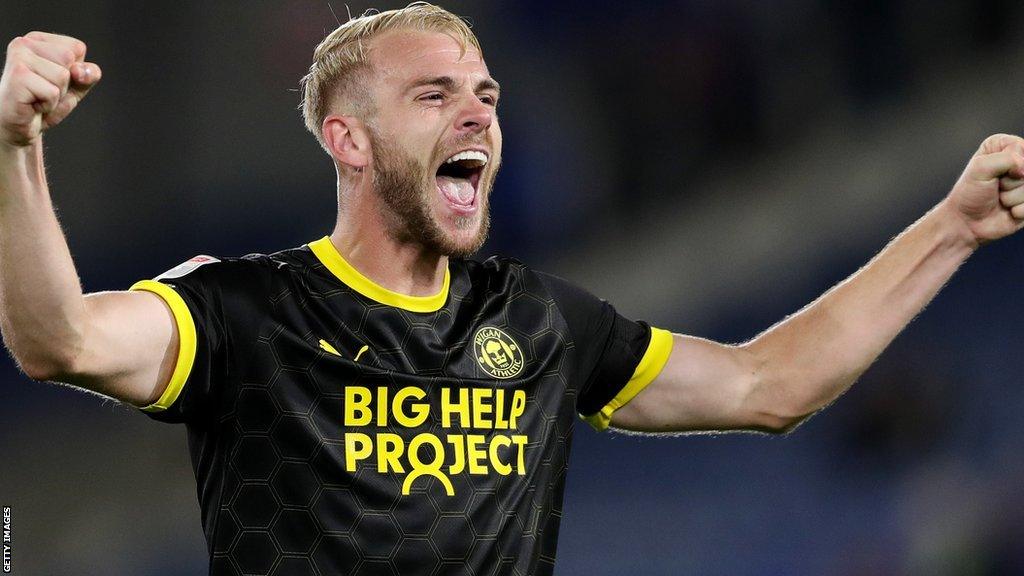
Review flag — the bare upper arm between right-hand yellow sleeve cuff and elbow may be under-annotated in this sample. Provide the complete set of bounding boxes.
[611,334,775,433]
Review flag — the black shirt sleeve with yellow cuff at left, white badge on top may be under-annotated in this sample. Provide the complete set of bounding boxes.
[129,255,227,422]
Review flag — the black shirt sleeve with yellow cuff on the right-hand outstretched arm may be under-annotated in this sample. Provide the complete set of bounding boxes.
[538,273,672,430]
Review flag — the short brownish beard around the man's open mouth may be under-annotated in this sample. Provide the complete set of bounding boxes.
[370,130,499,258]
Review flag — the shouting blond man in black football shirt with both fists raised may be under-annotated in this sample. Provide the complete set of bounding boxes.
[0,3,1024,575]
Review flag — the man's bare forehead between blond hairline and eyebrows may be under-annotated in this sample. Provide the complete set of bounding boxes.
[370,30,490,87]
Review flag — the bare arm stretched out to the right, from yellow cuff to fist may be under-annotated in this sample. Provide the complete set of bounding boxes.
[611,134,1024,433]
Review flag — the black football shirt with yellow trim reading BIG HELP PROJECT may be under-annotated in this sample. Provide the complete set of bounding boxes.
[131,237,672,576]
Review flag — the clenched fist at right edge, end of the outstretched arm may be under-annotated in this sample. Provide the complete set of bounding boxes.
[946,134,1024,244]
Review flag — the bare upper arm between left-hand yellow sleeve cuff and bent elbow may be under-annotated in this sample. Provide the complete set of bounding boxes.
[63,291,178,407]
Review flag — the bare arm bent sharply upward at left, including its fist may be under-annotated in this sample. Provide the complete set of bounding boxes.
[0,32,178,406]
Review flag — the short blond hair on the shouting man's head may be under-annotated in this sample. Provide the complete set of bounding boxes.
[299,2,483,154]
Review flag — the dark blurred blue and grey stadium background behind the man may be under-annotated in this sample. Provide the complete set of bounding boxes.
[0,0,1024,576]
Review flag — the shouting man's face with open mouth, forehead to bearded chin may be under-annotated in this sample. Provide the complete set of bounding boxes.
[367,31,502,256]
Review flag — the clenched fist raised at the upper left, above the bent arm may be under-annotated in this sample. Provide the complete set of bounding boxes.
[0,32,100,147]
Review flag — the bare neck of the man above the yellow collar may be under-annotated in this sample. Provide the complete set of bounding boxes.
[331,178,449,296]
